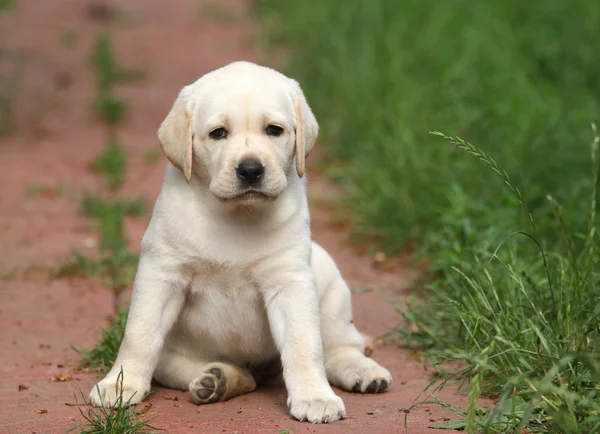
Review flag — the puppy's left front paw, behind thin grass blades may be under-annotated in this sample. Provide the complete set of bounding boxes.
[89,377,150,408]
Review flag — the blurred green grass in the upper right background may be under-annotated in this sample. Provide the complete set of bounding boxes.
[256,0,600,250]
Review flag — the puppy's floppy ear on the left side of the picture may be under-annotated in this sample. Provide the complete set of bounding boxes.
[158,86,195,182]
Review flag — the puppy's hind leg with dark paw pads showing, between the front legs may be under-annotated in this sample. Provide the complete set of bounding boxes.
[154,351,256,404]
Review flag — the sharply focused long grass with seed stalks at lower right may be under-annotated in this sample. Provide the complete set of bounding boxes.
[397,127,600,433]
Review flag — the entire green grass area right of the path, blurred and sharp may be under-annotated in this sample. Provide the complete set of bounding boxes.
[255,0,600,433]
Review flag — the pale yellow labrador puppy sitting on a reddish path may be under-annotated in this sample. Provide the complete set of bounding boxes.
[90,62,392,423]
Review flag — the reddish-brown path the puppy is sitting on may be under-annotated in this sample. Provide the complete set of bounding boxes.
[0,0,478,433]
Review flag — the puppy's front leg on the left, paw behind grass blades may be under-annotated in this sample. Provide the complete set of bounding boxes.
[89,256,186,407]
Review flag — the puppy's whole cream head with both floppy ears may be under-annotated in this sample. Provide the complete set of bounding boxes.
[158,62,319,202]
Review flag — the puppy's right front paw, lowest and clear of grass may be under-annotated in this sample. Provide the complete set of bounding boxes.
[289,391,346,423]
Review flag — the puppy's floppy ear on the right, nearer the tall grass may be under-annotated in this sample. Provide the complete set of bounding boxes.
[292,80,319,178]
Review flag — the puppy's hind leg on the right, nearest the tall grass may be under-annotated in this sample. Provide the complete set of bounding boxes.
[313,246,392,393]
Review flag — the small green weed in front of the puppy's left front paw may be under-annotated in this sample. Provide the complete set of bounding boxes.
[69,370,163,434]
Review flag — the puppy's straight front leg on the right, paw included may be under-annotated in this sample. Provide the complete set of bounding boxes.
[265,268,346,423]
